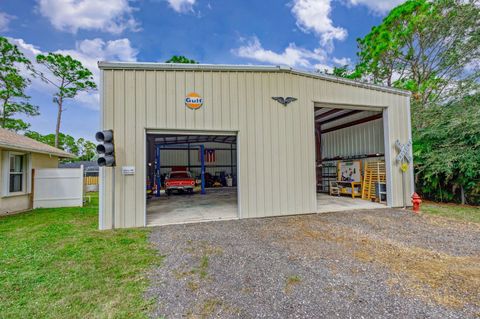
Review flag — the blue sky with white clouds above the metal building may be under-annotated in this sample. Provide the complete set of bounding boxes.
[0,0,403,140]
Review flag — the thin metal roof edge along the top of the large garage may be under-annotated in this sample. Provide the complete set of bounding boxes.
[98,61,411,96]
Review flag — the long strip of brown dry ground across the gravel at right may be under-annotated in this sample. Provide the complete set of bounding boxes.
[274,217,480,307]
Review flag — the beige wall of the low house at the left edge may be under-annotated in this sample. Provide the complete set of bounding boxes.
[0,149,58,215]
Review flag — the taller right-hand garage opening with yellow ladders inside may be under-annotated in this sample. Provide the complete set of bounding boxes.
[315,107,387,212]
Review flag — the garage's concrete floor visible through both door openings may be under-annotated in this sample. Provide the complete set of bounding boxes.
[147,187,386,226]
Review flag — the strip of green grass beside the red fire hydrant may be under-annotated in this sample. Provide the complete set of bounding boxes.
[421,201,480,223]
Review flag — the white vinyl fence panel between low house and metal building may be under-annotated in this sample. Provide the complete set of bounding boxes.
[33,166,83,208]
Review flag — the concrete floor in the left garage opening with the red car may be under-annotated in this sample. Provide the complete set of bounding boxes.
[147,187,238,226]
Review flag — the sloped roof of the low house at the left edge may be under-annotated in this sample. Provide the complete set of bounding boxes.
[0,128,75,158]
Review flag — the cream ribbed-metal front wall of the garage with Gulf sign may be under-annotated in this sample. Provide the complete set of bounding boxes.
[100,65,413,228]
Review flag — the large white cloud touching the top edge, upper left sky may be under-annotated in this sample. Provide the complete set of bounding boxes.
[37,0,138,34]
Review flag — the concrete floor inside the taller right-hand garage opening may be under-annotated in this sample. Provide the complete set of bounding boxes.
[317,193,386,213]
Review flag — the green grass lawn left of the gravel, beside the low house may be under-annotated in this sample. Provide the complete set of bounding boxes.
[0,195,160,318]
